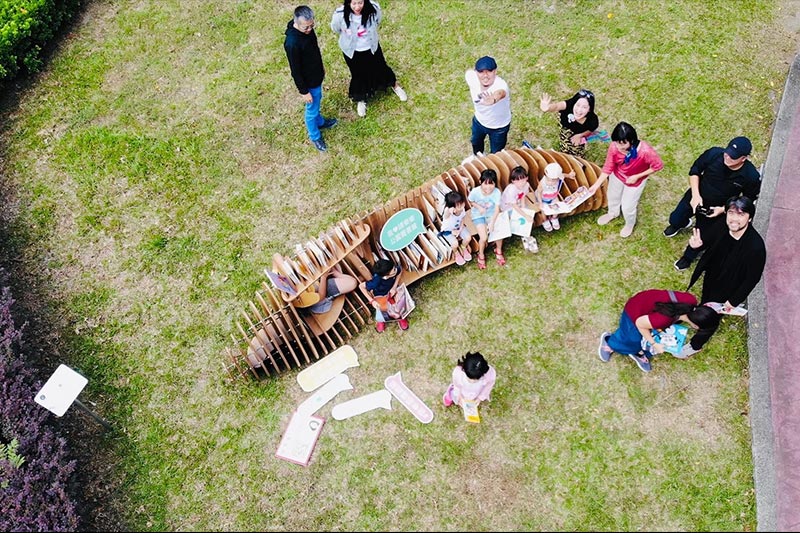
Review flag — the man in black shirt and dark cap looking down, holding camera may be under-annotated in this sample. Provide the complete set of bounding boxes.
[664,137,761,270]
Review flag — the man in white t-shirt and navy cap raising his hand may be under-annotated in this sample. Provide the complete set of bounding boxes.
[464,56,511,154]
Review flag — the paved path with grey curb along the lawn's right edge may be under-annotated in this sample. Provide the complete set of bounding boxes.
[748,52,800,531]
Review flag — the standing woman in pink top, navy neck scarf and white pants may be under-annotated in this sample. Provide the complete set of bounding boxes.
[589,122,664,237]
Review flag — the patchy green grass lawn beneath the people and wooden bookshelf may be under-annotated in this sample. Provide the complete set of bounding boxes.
[3,0,796,531]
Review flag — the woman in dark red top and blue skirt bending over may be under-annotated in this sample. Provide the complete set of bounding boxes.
[597,289,720,372]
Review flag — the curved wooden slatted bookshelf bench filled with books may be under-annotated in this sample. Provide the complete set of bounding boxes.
[223,147,608,379]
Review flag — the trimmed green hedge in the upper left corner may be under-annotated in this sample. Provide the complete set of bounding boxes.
[0,0,81,80]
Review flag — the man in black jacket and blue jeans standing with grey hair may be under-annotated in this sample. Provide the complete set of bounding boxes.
[283,6,337,152]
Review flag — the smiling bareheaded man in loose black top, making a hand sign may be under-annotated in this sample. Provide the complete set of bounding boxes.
[678,196,767,358]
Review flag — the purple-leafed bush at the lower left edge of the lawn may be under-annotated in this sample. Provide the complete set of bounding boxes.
[0,271,78,531]
